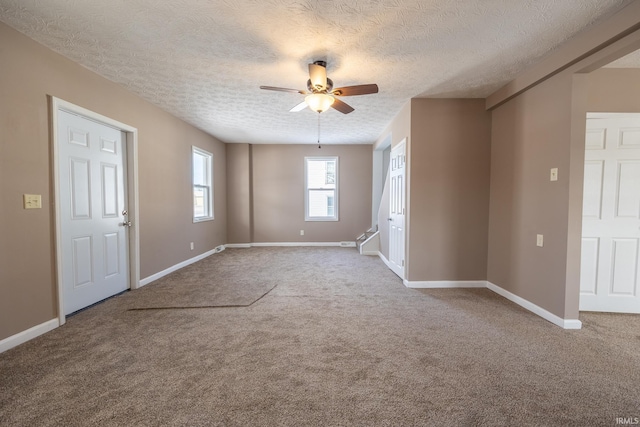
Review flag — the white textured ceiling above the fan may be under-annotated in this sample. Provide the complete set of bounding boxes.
[0,0,632,144]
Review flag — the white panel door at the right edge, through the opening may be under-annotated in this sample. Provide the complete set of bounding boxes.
[580,114,640,313]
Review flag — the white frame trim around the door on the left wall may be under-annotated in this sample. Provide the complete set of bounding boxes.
[49,96,140,325]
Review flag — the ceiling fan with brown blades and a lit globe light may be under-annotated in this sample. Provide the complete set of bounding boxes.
[260,61,378,114]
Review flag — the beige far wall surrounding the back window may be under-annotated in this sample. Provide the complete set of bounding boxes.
[227,144,372,243]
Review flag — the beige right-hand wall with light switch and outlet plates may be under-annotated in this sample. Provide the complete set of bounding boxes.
[488,73,584,319]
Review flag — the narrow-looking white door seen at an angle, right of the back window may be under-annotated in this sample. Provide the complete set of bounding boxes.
[389,140,406,279]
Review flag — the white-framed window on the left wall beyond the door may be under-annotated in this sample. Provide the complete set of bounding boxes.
[192,147,213,222]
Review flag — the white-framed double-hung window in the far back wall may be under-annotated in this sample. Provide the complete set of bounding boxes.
[304,157,338,221]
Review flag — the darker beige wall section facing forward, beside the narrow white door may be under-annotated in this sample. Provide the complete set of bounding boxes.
[405,99,491,281]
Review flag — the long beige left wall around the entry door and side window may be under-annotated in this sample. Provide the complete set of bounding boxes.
[0,23,226,340]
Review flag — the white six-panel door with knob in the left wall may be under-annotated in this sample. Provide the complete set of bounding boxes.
[58,110,129,315]
